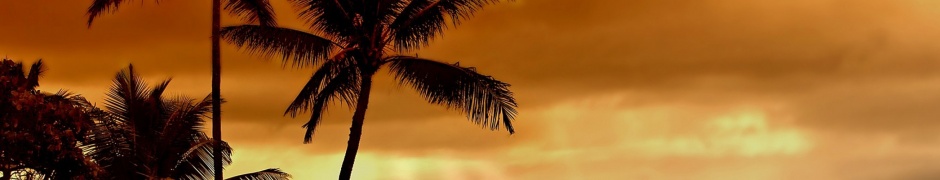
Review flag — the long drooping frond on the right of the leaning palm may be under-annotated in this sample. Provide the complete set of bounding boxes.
[389,56,517,134]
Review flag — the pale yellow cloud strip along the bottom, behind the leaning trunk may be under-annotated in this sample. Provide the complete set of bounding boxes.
[226,148,512,180]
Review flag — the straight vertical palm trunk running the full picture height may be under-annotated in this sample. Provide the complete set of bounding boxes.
[212,0,223,180]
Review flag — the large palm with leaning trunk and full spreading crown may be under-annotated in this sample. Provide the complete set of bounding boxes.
[221,0,516,179]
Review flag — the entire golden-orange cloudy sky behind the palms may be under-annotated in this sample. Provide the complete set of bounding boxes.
[0,0,940,180]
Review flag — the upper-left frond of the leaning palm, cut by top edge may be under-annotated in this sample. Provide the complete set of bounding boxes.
[290,0,361,41]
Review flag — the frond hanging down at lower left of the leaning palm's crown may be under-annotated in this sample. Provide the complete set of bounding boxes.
[284,59,360,143]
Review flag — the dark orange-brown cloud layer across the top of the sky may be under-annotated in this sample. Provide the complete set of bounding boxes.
[12,0,937,129]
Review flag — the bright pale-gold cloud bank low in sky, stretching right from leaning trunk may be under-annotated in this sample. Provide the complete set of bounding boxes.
[220,95,815,179]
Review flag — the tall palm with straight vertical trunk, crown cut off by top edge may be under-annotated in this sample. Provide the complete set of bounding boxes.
[88,0,276,180]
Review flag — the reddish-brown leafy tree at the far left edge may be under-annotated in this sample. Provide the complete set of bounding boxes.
[0,59,97,180]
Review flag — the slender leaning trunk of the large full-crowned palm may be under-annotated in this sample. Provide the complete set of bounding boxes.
[339,73,372,180]
